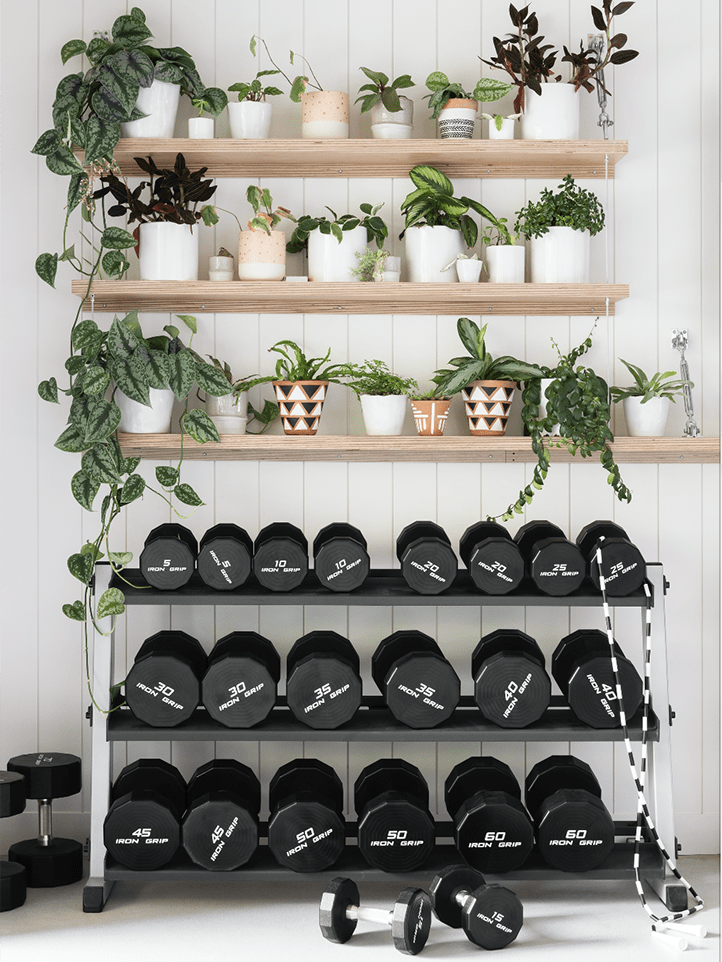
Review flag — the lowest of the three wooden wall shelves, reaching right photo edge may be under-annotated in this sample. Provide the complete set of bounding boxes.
[120,434,720,464]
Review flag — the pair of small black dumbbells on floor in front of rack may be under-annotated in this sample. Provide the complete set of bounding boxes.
[318,865,524,955]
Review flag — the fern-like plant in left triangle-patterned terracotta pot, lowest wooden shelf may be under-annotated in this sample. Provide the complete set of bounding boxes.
[246,341,345,437]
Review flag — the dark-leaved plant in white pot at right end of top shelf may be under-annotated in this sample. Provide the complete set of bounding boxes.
[480,0,639,140]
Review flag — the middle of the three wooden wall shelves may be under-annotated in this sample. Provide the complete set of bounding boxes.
[72,281,629,316]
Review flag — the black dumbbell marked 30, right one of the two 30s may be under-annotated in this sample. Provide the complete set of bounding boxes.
[201,631,281,728]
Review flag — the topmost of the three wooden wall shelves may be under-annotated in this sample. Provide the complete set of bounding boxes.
[77,138,627,178]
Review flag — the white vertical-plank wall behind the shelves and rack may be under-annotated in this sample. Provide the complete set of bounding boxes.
[0,0,719,852]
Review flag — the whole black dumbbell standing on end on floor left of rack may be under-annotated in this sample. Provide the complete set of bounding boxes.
[8,752,83,888]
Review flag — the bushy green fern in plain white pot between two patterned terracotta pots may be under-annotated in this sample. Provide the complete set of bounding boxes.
[342,360,419,436]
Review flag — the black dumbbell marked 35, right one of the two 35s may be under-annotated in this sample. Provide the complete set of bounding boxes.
[371,631,461,728]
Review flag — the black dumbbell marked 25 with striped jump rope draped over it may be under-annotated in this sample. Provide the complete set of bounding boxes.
[577,521,647,598]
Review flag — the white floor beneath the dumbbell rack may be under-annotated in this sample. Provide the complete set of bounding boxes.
[0,856,720,962]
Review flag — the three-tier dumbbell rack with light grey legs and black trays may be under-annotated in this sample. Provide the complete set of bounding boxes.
[83,563,687,912]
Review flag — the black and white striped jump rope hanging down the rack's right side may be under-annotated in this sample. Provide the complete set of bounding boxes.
[596,545,706,949]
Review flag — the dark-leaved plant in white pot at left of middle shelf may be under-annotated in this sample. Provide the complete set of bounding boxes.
[93,154,216,281]
